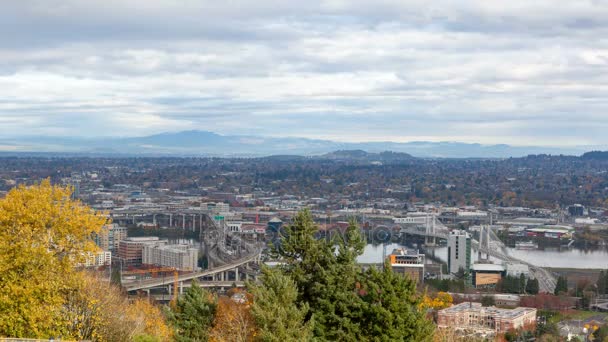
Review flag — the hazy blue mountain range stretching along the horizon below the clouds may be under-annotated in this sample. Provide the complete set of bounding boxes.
[0,131,597,161]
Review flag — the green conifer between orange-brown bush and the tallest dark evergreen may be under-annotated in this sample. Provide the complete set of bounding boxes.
[248,268,314,342]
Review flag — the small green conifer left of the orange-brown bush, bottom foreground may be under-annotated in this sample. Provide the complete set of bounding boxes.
[167,281,217,342]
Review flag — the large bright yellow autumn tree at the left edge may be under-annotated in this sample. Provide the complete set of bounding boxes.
[0,180,106,338]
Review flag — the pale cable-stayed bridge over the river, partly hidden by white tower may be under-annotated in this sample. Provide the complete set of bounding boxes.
[393,214,557,293]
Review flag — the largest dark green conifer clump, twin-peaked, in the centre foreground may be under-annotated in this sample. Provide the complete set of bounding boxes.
[274,210,433,341]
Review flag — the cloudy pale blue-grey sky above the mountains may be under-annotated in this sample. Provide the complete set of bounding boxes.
[0,0,608,146]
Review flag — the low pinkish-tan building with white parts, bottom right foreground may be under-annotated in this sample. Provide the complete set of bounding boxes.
[437,302,536,334]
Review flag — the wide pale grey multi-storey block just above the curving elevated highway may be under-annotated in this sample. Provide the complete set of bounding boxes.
[142,241,198,271]
